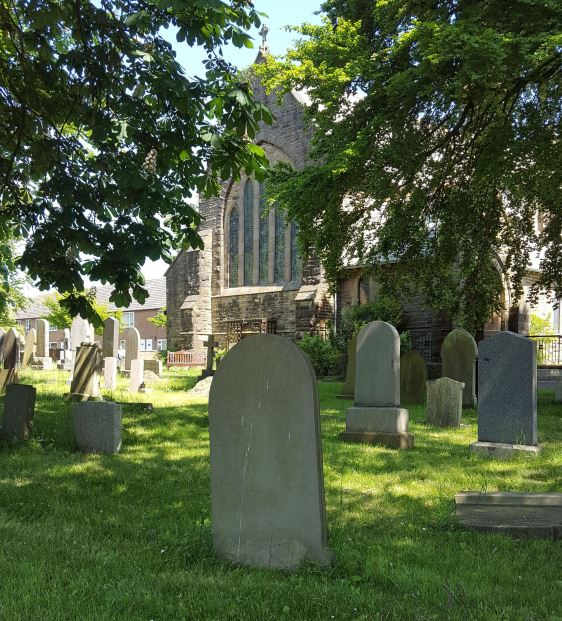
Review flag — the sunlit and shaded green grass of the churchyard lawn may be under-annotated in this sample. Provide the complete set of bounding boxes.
[0,370,562,621]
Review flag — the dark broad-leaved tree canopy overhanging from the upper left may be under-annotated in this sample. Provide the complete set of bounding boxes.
[0,0,271,323]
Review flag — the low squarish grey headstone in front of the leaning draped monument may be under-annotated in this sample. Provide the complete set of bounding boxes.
[74,401,121,455]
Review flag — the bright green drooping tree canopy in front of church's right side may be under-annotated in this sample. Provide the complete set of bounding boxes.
[257,0,562,329]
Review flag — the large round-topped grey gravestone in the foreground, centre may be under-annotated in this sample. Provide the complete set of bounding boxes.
[209,334,332,569]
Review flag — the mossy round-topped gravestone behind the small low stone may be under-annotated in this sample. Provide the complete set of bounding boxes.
[441,328,478,408]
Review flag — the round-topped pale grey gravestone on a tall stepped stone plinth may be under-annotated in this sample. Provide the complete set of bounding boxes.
[340,321,414,449]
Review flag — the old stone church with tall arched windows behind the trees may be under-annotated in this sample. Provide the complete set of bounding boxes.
[166,43,552,363]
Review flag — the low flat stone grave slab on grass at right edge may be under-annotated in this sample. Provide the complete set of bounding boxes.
[455,492,562,539]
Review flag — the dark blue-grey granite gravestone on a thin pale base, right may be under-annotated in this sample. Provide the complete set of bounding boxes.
[470,332,539,457]
